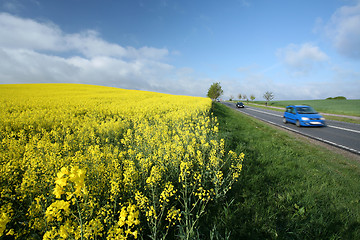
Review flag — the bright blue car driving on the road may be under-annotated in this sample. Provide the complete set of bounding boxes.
[283,105,326,127]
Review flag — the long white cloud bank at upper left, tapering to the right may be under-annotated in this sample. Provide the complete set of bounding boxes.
[0,13,169,60]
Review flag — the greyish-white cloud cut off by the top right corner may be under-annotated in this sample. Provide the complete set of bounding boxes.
[318,1,360,60]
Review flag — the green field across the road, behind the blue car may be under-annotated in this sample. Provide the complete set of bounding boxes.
[254,99,360,116]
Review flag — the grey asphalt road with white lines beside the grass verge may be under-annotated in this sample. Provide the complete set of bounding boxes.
[223,102,360,155]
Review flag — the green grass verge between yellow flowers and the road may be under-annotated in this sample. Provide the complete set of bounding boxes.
[208,103,360,239]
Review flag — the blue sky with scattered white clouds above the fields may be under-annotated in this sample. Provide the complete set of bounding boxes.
[0,0,360,100]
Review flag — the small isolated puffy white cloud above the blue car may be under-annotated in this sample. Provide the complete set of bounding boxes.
[276,43,329,76]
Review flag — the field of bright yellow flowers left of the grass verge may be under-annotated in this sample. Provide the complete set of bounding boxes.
[0,84,244,239]
